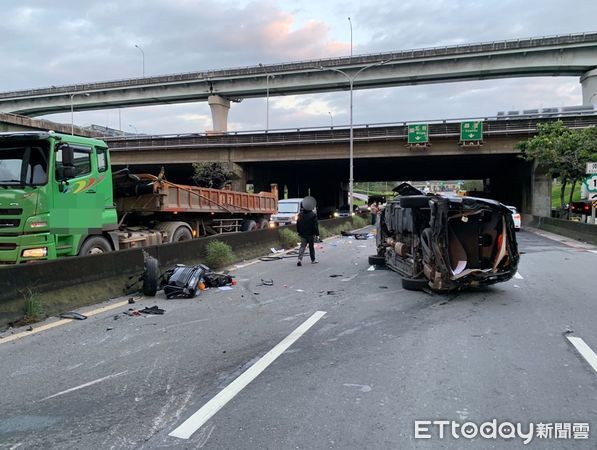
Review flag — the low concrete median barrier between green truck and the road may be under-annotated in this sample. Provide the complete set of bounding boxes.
[0,218,350,329]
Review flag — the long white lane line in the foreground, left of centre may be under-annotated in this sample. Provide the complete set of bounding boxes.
[169,311,326,439]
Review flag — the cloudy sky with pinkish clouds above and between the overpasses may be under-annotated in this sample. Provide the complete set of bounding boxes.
[0,0,597,134]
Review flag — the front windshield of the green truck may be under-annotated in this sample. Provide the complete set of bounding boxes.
[0,142,48,187]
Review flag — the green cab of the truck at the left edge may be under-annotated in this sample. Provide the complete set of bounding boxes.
[0,132,118,264]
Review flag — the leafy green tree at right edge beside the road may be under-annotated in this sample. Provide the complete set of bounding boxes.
[516,120,597,211]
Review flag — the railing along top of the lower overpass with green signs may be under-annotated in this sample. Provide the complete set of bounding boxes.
[104,113,597,152]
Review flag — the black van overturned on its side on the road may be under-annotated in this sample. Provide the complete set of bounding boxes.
[369,183,519,292]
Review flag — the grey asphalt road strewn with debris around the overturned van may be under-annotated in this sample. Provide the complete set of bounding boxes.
[0,232,597,449]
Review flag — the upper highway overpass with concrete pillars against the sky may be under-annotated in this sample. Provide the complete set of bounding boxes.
[0,33,597,131]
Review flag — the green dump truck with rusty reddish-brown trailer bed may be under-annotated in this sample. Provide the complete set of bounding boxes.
[0,131,278,264]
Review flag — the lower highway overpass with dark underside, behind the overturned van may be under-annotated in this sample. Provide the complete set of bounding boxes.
[106,114,597,220]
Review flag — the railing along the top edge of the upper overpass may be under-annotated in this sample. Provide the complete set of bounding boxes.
[0,32,597,99]
